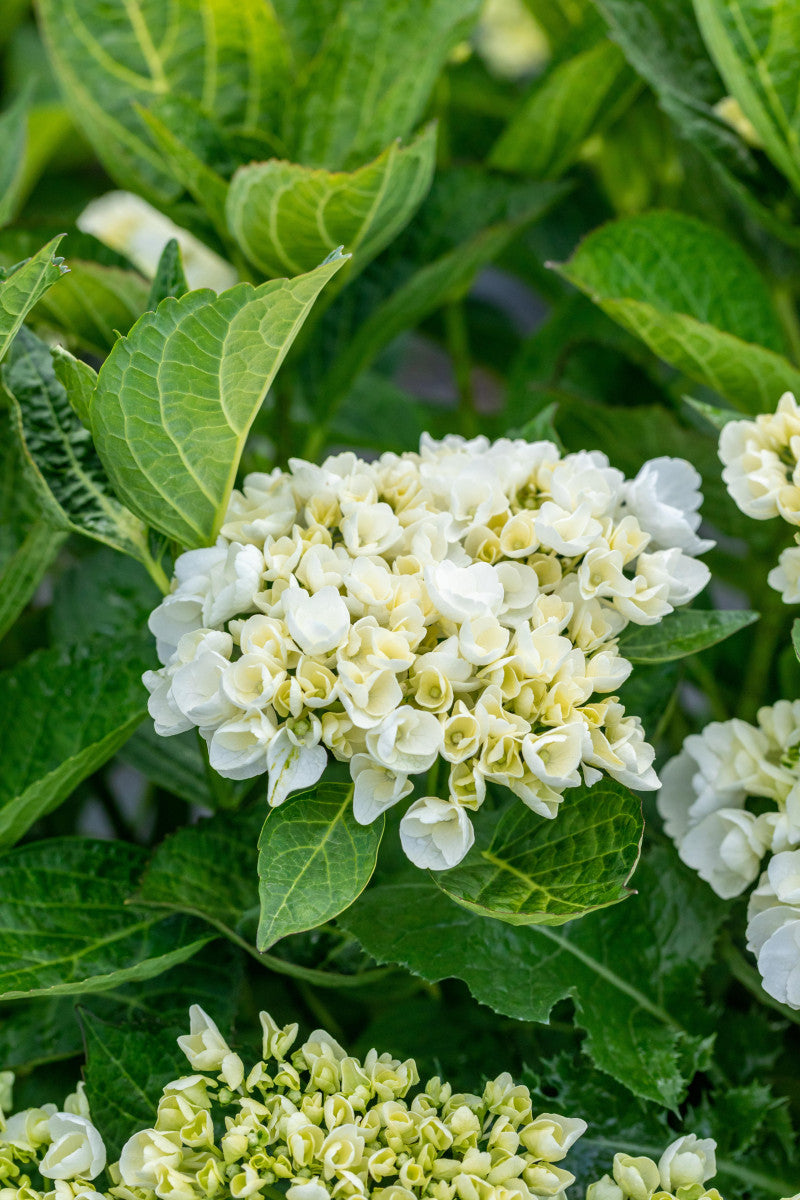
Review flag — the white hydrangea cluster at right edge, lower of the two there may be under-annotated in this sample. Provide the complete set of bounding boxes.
[657,700,800,1008]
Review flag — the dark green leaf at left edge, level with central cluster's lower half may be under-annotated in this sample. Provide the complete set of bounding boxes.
[0,637,150,846]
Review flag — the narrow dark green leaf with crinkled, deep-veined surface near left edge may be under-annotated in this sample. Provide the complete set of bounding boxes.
[2,329,146,558]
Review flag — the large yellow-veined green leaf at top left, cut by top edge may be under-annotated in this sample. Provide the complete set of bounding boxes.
[38,0,288,203]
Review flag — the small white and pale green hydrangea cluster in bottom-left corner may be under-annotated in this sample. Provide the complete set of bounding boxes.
[0,1072,106,1200]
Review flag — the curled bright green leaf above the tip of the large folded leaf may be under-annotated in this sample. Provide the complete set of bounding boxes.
[227,125,437,276]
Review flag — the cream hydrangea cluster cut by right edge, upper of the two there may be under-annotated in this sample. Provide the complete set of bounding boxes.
[720,391,800,604]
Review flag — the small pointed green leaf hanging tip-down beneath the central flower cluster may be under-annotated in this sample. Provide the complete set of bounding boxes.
[257,784,384,950]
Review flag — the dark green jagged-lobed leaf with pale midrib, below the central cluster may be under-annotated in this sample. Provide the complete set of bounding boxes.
[338,844,727,1108]
